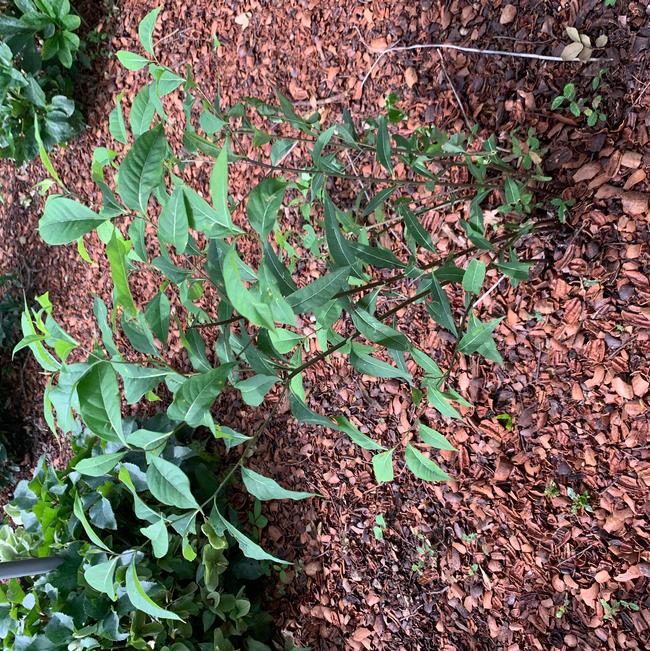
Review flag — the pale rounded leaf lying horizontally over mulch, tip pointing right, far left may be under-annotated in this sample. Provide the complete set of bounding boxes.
[38,195,106,244]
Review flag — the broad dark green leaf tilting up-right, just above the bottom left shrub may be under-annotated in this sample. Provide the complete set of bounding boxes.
[167,364,232,427]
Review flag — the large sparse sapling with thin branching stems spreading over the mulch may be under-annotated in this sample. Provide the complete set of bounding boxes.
[7,3,545,649]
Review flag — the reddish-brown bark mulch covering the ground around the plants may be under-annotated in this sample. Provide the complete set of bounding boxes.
[0,0,650,651]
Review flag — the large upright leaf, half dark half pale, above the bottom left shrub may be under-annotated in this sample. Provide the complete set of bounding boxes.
[77,362,124,443]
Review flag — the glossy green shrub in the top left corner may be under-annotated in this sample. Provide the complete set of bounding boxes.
[0,0,82,163]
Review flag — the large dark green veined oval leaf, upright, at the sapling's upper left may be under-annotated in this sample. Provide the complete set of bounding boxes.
[117,124,167,213]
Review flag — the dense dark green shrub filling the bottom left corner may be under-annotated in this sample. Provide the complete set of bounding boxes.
[0,416,273,651]
